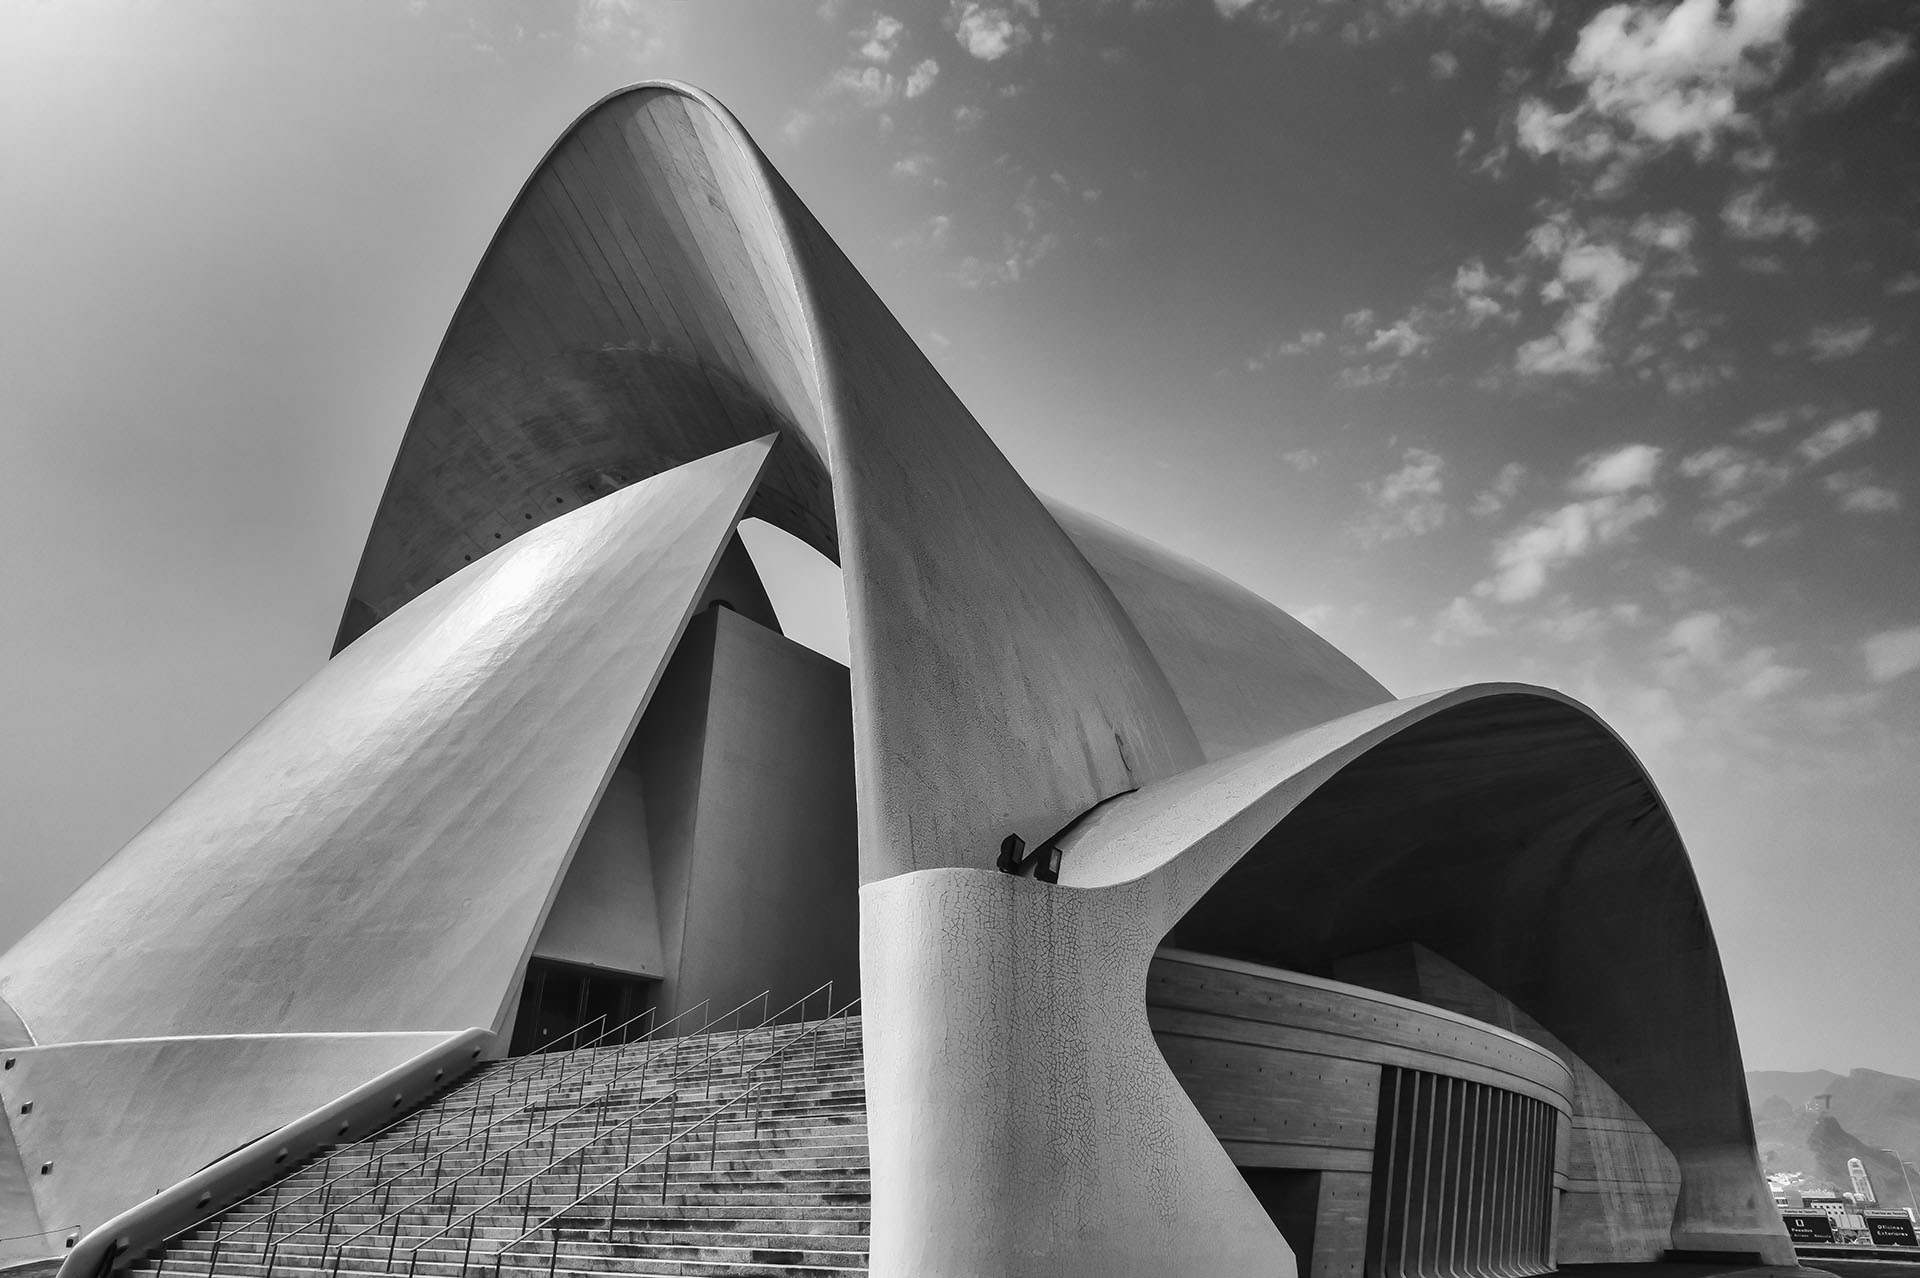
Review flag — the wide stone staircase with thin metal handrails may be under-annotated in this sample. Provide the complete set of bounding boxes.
[132,1006,870,1278]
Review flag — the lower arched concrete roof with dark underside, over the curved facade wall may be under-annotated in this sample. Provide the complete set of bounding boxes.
[1060,685,1778,1245]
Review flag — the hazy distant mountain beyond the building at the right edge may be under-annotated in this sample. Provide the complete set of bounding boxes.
[1747,1069,1920,1209]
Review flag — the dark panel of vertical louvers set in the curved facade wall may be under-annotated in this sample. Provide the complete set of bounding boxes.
[1367,1067,1557,1278]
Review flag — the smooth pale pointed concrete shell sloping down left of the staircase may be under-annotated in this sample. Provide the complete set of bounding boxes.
[0,439,772,1042]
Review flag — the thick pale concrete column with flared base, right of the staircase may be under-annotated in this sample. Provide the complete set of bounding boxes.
[860,869,1296,1278]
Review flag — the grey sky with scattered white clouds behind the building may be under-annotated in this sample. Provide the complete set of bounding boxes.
[0,0,1920,1077]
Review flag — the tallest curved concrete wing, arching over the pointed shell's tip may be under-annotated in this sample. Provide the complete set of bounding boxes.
[330,84,1200,879]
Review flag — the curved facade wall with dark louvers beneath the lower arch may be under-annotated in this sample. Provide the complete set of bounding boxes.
[1146,950,1572,1278]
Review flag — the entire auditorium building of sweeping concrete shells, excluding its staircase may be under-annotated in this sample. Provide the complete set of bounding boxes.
[0,83,1793,1278]
